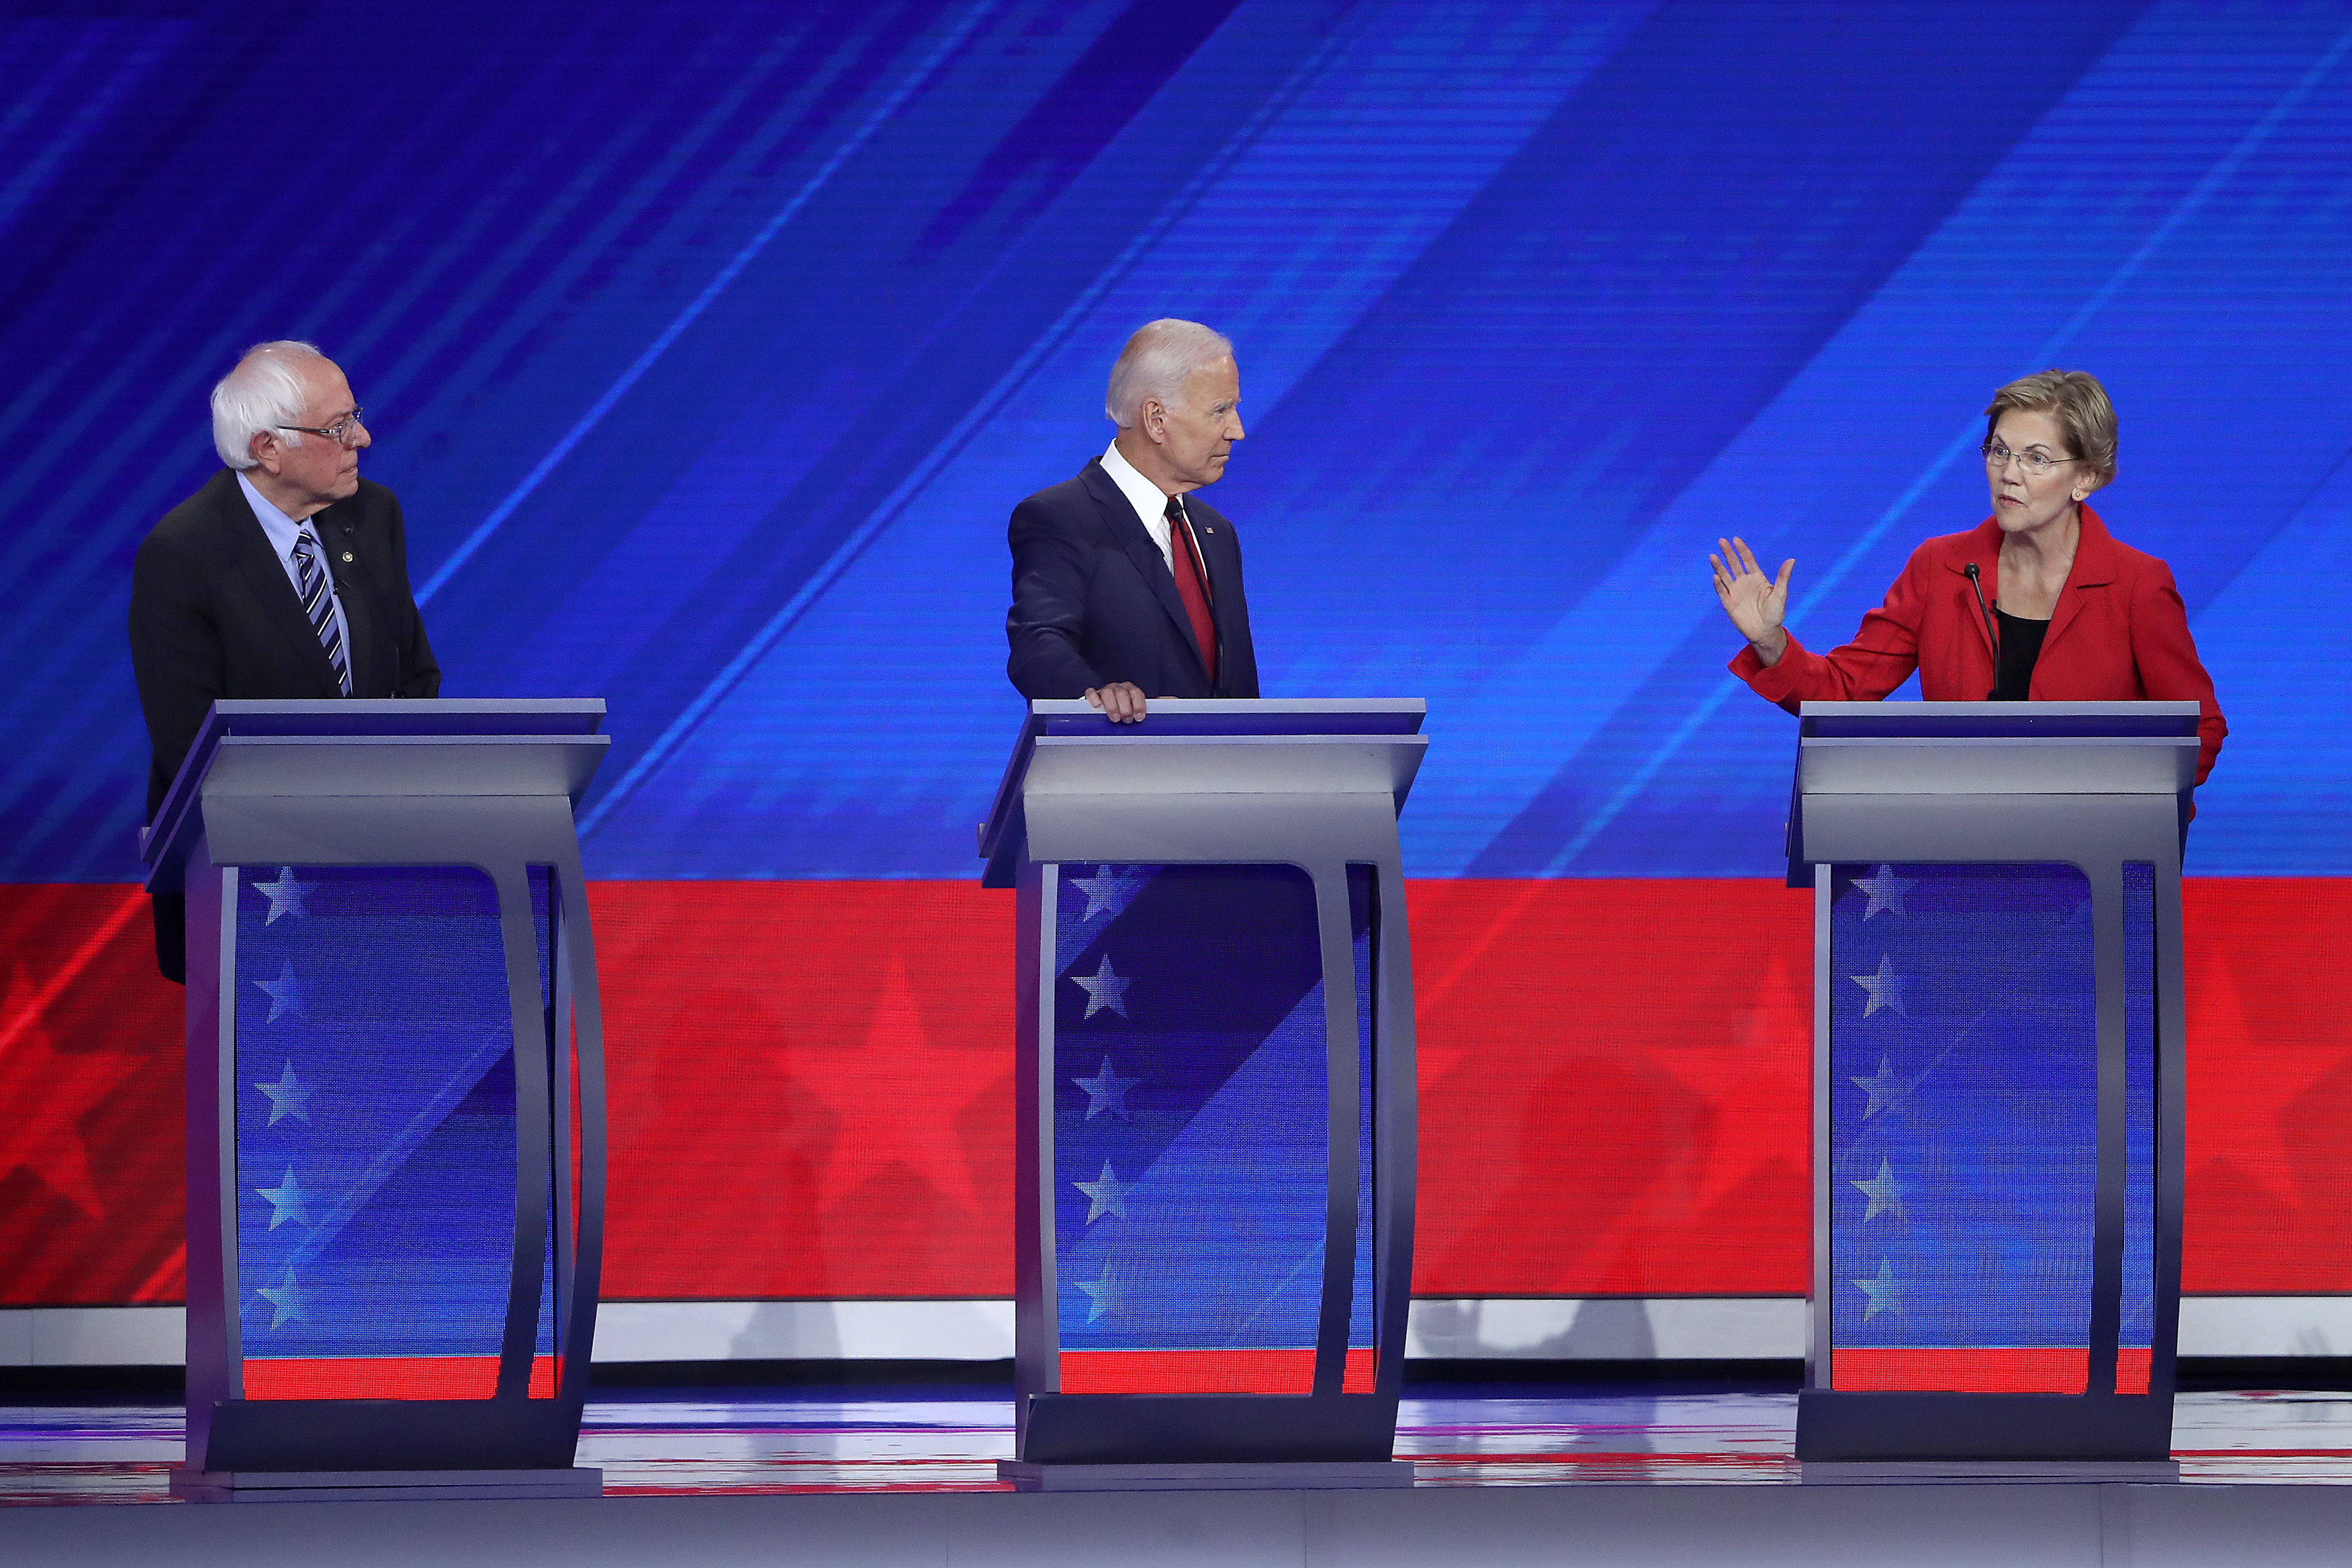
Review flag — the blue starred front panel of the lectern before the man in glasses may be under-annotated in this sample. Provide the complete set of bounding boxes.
[235,865,550,1399]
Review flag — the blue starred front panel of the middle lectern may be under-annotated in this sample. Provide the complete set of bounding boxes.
[1054,865,1369,1394]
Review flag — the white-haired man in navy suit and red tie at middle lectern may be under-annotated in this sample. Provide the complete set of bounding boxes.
[1004,319,1258,724]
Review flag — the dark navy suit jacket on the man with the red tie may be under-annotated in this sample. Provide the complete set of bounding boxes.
[1004,459,1258,698]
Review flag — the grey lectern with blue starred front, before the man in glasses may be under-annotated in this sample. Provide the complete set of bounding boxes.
[141,698,609,1502]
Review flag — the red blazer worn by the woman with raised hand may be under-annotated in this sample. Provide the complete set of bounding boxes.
[1731,506,2230,783]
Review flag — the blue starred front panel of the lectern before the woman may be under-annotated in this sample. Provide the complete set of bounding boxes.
[1830,865,2098,1392]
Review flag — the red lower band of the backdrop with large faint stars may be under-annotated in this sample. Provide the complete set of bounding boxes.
[0,879,2352,1304]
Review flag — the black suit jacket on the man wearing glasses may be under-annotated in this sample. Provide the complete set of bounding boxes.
[132,468,440,980]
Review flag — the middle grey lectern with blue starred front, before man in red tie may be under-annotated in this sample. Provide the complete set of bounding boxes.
[981,698,1428,1485]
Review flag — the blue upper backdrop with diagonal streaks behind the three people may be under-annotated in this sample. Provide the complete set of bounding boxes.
[0,0,2352,882]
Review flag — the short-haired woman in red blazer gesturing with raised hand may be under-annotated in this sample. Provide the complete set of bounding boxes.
[1707,369,2230,783]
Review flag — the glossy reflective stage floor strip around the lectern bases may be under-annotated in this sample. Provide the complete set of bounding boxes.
[0,1385,2352,1505]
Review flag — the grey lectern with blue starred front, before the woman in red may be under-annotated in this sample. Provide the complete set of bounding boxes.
[1790,703,2197,1465]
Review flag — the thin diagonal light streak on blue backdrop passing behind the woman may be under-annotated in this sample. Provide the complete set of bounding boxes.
[1543,28,2352,877]
